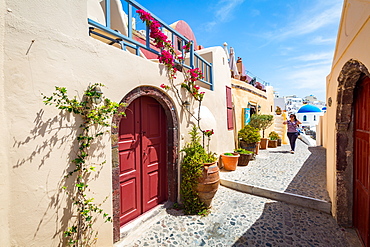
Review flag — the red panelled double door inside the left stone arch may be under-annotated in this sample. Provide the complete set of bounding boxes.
[119,97,167,226]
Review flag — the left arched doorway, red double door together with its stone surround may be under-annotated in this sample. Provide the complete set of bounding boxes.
[112,86,178,242]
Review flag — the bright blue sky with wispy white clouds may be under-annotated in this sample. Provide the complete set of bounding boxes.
[137,0,343,100]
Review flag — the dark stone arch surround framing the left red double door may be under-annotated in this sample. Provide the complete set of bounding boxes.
[111,86,179,242]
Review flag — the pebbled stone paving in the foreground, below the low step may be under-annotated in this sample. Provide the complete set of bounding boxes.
[125,186,351,247]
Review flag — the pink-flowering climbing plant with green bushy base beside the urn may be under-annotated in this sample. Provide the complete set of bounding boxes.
[136,9,216,215]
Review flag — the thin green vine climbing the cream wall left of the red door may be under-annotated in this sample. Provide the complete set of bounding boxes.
[43,83,126,247]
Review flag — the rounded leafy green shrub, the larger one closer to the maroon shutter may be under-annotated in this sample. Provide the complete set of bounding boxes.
[238,125,261,154]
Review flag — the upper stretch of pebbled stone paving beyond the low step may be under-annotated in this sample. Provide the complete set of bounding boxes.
[220,140,330,202]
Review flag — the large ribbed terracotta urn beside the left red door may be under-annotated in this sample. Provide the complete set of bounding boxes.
[196,162,220,207]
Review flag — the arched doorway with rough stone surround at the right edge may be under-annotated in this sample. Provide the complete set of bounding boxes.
[335,60,370,242]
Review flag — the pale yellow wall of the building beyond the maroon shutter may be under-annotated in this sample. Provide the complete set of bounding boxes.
[231,79,275,138]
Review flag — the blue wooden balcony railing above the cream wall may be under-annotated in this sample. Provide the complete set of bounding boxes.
[88,0,213,90]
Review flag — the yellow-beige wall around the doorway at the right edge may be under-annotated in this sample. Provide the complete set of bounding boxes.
[323,0,370,215]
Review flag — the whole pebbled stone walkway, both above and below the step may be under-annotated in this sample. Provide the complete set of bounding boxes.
[120,141,359,247]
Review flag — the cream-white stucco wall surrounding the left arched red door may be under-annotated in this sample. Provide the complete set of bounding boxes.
[0,0,233,246]
